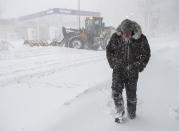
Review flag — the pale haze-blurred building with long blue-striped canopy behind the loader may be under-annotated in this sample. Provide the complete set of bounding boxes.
[0,8,100,40]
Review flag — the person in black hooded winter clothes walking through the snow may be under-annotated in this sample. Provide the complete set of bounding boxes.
[106,19,150,122]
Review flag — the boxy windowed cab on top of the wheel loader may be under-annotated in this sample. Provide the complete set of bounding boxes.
[85,17,104,36]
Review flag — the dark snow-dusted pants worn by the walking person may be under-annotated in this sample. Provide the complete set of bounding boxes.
[112,69,139,114]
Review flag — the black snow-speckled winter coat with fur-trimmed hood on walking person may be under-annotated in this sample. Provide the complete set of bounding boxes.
[106,21,150,76]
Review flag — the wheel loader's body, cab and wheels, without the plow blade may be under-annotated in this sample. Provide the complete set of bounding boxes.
[58,17,114,50]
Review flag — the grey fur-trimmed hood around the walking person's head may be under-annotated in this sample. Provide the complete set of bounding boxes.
[116,19,142,40]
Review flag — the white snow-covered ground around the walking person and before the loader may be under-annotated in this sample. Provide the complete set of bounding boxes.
[0,39,179,131]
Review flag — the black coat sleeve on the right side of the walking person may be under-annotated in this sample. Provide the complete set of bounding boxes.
[135,36,151,72]
